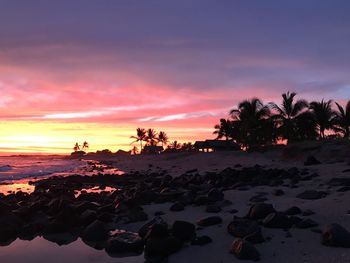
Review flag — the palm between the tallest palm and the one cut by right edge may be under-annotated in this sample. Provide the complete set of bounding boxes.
[310,100,336,139]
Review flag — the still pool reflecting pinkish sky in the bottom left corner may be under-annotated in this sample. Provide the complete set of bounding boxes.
[0,237,144,263]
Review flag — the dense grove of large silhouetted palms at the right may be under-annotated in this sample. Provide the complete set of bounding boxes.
[214,92,350,149]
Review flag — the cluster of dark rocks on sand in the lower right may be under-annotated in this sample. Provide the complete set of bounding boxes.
[227,203,350,260]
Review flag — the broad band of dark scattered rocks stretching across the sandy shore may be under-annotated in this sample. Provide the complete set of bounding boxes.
[0,157,350,262]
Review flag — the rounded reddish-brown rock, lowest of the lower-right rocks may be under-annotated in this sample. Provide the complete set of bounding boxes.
[230,238,260,261]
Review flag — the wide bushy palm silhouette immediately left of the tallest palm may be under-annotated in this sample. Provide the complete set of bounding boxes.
[230,98,271,148]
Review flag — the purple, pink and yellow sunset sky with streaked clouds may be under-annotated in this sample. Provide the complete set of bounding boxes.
[0,0,350,153]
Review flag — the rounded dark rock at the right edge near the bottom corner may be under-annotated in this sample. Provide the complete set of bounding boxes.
[321,224,350,248]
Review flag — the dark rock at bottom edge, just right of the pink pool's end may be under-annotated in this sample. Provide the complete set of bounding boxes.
[144,236,182,259]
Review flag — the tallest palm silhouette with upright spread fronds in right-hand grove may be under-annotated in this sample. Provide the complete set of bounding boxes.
[270,91,308,142]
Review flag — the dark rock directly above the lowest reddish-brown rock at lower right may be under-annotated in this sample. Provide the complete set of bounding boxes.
[227,217,264,243]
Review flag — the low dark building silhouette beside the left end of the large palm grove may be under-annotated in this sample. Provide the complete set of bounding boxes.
[194,140,241,152]
